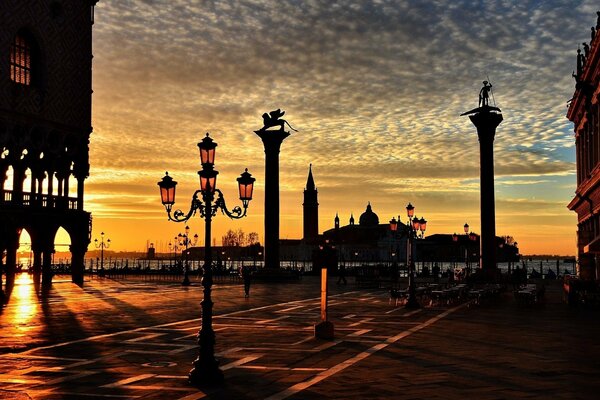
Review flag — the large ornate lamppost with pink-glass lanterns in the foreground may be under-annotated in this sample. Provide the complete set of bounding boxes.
[158,133,256,385]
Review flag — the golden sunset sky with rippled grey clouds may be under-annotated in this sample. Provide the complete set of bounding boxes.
[79,0,598,255]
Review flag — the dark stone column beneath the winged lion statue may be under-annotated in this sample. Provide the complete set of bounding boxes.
[254,129,290,268]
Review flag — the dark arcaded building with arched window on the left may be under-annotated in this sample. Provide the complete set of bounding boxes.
[0,0,97,284]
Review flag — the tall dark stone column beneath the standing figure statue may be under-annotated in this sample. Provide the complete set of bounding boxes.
[469,106,502,271]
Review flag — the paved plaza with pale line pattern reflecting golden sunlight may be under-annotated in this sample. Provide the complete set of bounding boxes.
[0,274,600,400]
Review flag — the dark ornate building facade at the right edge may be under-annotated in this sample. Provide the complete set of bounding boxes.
[567,10,600,279]
